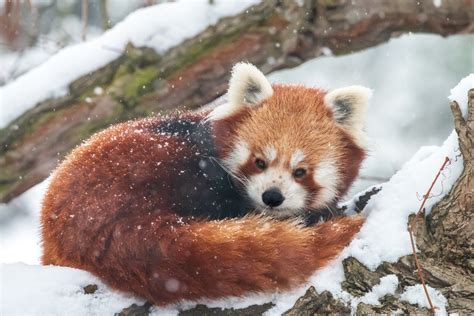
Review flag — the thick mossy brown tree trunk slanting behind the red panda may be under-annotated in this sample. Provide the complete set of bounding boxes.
[0,0,474,202]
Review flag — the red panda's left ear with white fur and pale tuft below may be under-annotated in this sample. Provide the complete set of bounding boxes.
[208,62,273,120]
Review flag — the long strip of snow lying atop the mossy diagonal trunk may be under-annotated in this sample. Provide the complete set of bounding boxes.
[0,0,259,128]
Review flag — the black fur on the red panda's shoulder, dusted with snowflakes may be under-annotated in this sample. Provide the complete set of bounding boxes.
[155,118,252,219]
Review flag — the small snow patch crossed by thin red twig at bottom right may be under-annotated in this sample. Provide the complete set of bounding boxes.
[400,284,448,315]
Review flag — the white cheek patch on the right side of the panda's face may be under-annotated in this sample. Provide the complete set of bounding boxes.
[314,159,340,207]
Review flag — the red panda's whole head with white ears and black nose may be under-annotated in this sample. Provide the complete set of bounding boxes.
[209,64,370,218]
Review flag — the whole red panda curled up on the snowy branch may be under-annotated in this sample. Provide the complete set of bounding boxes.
[41,63,370,305]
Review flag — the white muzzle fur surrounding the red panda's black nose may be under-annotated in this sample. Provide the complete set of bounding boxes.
[246,167,308,218]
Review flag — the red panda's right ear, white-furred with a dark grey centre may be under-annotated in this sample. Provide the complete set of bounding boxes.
[324,86,372,147]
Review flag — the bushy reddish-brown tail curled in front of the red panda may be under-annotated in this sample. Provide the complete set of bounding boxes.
[43,214,363,305]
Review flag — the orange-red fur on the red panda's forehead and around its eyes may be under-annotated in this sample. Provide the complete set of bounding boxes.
[217,85,365,207]
